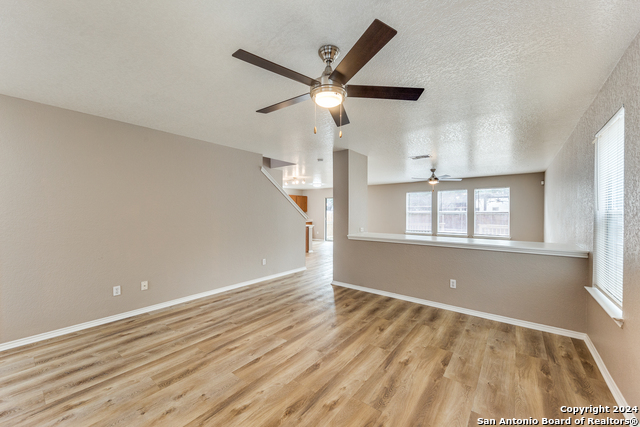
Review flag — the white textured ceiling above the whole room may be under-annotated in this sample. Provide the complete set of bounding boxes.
[0,0,640,187]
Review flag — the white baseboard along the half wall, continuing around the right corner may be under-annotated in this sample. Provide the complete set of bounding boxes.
[331,280,634,412]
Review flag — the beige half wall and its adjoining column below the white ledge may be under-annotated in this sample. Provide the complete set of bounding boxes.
[333,151,588,332]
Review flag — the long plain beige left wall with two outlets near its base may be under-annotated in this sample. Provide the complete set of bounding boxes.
[0,96,305,342]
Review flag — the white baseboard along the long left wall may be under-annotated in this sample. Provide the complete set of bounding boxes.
[0,267,307,351]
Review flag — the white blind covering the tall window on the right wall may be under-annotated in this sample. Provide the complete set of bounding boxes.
[594,109,624,307]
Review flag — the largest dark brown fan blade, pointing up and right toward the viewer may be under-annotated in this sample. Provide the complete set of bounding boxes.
[329,19,398,84]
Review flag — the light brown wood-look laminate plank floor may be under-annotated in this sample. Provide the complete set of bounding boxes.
[0,243,615,427]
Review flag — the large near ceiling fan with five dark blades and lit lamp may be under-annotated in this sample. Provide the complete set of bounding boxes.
[232,19,424,126]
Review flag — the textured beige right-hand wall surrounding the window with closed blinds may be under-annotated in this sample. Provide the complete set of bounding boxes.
[545,32,640,405]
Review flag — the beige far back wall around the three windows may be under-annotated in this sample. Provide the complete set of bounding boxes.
[368,173,544,242]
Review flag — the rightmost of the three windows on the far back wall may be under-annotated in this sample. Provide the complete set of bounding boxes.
[473,188,511,237]
